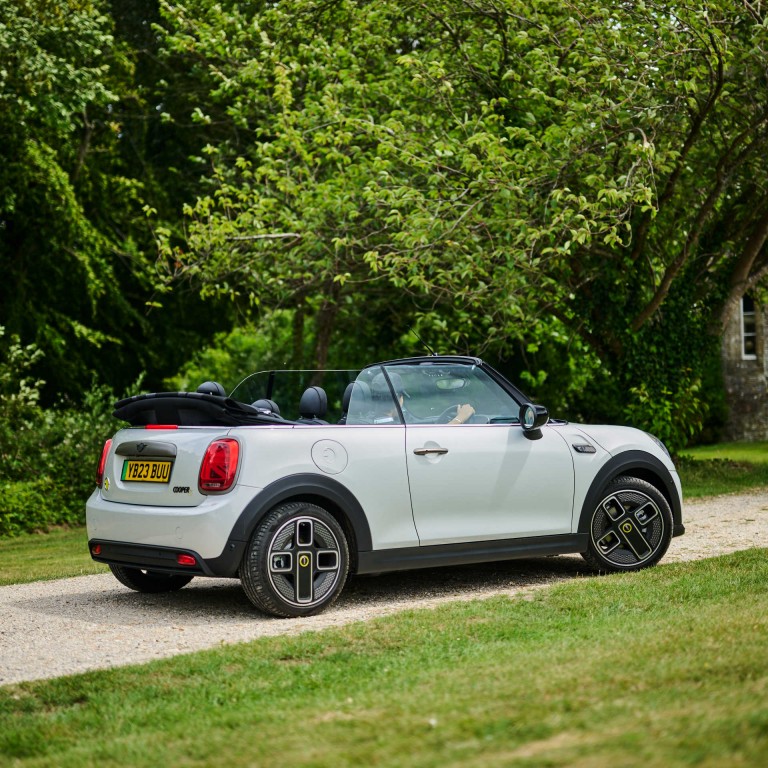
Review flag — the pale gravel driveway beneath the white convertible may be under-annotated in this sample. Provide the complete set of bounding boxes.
[0,490,768,685]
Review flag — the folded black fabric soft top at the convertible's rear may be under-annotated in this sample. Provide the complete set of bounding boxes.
[112,392,284,427]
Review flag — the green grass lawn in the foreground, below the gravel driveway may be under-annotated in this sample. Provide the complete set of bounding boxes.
[0,550,768,768]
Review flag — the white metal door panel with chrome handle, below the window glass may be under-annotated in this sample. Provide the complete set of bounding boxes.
[405,424,574,545]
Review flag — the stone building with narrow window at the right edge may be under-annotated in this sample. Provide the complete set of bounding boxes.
[722,296,768,441]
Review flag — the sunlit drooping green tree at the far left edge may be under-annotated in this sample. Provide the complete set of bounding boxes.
[0,0,140,396]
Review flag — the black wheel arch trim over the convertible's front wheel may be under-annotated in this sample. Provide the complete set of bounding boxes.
[578,451,685,536]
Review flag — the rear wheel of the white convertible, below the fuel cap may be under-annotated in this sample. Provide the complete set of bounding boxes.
[240,502,349,618]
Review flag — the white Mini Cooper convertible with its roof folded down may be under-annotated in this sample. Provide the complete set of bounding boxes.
[86,356,685,617]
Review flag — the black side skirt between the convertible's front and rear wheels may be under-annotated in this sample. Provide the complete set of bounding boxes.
[357,533,587,573]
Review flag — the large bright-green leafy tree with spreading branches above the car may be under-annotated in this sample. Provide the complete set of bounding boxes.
[160,0,768,444]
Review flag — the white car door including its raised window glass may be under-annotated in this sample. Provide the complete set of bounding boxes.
[378,360,574,545]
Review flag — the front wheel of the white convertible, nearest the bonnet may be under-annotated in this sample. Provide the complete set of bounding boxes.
[581,477,672,573]
